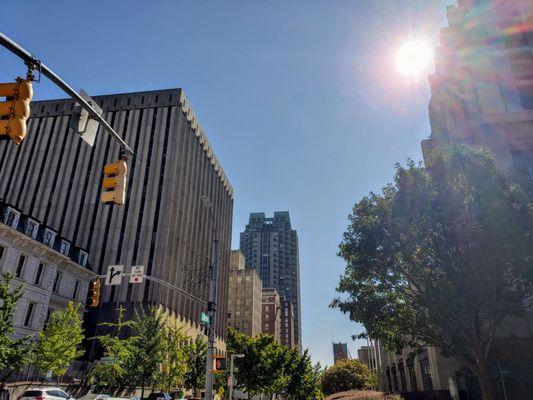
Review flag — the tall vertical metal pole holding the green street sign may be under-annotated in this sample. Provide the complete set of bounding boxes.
[205,235,218,400]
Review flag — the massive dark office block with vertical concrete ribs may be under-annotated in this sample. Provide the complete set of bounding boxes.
[0,89,233,348]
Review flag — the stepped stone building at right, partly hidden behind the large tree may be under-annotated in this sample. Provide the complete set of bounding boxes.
[378,0,533,399]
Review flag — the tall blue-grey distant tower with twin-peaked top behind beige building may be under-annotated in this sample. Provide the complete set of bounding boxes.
[240,211,302,348]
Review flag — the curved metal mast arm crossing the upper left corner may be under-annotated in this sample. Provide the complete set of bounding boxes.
[0,32,133,155]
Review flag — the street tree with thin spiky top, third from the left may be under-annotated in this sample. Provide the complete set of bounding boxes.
[91,306,134,387]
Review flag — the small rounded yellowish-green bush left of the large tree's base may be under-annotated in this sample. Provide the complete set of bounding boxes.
[322,360,377,396]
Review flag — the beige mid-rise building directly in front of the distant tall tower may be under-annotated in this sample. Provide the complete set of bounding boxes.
[228,250,263,336]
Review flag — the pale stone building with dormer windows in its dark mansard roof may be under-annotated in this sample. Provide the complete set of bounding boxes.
[0,204,96,337]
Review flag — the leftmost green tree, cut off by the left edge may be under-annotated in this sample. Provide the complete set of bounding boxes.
[0,274,30,375]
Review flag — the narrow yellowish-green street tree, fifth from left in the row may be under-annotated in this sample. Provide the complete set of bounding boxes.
[159,324,188,392]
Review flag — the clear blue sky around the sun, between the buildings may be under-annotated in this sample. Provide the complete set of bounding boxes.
[0,0,455,365]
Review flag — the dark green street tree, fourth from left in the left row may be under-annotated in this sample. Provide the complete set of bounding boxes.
[126,307,166,398]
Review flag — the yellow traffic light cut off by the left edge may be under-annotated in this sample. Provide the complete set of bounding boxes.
[0,78,33,144]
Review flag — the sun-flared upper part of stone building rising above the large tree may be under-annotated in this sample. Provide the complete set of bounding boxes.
[422,0,533,179]
